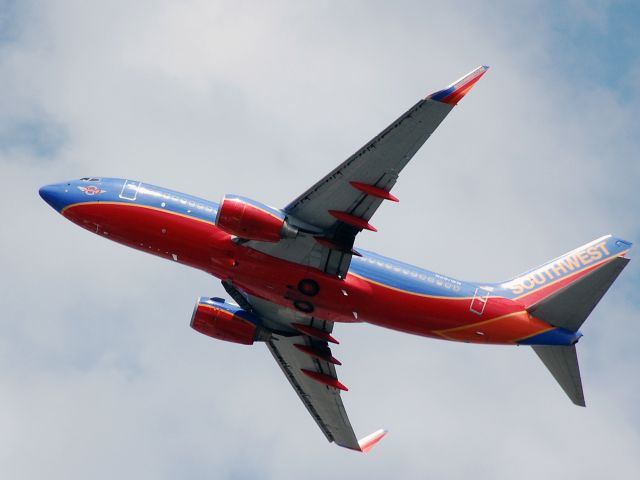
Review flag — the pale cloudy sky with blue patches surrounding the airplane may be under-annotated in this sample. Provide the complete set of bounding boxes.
[0,0,640,480]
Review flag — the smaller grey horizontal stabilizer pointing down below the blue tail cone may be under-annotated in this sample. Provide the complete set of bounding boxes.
[532,345,585,407]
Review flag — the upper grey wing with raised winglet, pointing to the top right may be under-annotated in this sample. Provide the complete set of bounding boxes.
[250,66,488,277]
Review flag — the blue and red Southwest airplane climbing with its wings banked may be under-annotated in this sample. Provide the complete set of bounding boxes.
[39,66,631,453]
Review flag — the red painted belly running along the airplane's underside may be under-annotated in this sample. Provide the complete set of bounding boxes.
[64,203,548,343]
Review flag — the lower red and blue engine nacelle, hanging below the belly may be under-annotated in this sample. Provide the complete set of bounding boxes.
[191,297,263,345]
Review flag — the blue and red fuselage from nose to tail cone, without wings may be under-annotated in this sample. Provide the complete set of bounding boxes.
[40,178,580,345]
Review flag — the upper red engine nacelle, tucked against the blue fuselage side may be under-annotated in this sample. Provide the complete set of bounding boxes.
[216,195,298,242]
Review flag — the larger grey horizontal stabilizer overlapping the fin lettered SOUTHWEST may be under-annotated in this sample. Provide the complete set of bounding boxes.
[527,257,629,332]
